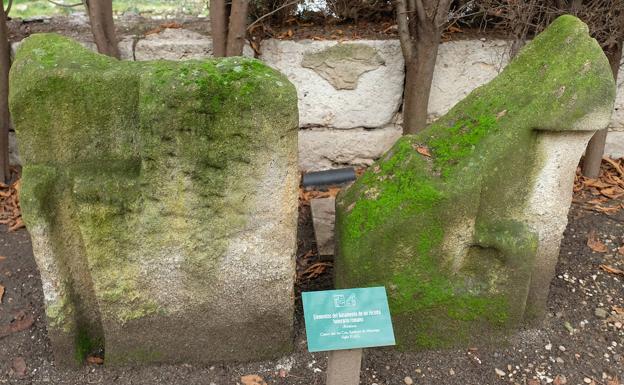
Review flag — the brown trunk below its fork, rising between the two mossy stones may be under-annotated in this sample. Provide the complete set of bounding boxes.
[403,31,440,135]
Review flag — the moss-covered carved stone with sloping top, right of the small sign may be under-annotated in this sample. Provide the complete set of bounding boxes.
[336,16,615,349]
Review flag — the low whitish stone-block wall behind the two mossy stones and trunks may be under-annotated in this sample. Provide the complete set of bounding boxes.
[8,29,624,171]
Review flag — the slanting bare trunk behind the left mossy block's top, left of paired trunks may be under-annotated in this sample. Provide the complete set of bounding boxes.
[84,0,120,59]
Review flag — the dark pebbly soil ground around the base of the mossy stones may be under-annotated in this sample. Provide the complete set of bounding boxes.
[0,172,624,385]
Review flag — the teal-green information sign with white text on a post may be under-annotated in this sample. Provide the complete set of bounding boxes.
[301,287,395,352]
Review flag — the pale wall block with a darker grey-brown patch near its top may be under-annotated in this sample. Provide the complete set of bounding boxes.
[261,39,404,129]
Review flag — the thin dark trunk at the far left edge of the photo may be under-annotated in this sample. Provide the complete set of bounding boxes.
[0,3,11,183]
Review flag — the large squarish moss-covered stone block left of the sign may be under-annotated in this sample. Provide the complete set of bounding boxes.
[10,34,298,364]
